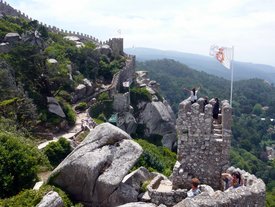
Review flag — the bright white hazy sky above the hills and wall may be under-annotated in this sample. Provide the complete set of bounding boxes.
[7,0,275,66]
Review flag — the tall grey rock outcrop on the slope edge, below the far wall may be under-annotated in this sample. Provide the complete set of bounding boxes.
[136,71,177,149]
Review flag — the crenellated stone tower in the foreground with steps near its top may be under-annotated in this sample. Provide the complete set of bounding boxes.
[173,99,232,189]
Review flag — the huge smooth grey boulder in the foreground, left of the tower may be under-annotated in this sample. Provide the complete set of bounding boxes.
[50,123,142,207]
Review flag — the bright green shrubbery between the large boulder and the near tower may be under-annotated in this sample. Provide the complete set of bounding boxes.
[134,139,176,176]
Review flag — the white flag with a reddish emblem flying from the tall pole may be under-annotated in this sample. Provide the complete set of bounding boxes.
[209,45,233,69]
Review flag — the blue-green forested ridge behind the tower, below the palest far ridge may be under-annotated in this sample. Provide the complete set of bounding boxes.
[136,59,275,118]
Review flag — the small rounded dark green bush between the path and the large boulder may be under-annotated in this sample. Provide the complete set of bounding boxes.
[43,137,72,166]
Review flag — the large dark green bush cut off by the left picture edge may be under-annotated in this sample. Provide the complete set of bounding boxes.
[0,132,49,198]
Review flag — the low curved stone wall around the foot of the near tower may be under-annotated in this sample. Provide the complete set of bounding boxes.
[148,167,266,207]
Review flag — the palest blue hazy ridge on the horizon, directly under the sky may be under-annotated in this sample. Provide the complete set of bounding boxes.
[125,47,275,84]
